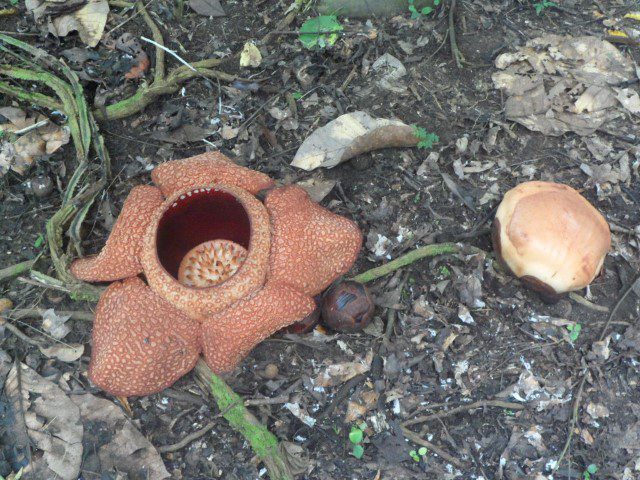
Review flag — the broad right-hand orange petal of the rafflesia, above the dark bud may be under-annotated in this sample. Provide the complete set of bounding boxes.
[265,186,362,296]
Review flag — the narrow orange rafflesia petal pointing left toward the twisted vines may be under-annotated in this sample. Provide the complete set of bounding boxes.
[71,185,163,282]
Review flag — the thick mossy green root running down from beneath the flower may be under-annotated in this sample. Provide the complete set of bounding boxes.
[195,360,293,480]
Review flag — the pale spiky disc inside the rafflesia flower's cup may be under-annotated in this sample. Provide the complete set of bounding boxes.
[178,240,247,288]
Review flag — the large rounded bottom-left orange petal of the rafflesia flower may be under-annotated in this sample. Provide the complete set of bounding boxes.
[89,277,200,396]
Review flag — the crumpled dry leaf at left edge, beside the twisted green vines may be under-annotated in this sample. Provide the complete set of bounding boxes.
[0,107,69,178]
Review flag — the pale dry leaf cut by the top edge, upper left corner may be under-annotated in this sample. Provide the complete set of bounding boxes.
[25,0,109,47]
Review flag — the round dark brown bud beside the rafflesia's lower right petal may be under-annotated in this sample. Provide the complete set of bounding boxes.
[322,280,375,333]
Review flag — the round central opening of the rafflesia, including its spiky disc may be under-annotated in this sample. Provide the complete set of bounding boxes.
[156,188,251,287]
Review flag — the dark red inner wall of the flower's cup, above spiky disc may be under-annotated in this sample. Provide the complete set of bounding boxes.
[156,189,251,279]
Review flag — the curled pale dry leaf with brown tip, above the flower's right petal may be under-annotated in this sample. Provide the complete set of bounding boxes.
[291,111,420,170]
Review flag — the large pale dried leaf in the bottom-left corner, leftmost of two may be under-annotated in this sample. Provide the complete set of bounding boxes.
[4,364,83,480]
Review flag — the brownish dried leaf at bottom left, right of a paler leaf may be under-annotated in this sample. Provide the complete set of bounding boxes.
[71,394,170,480]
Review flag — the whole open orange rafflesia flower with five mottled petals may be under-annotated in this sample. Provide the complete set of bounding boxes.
[71,153,362,396]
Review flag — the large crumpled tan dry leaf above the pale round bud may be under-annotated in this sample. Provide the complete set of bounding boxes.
[492,35,638,136]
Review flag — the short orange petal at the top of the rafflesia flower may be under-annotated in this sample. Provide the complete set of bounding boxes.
[151,152,273,197]
